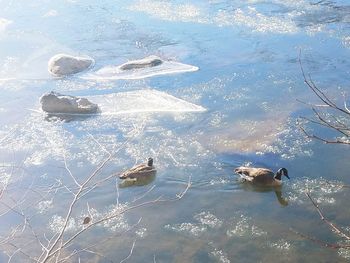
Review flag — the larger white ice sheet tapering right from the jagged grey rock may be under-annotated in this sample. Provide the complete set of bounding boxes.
[89,90,206,115]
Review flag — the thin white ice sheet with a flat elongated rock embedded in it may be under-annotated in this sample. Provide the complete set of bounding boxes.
[81,56,198,80]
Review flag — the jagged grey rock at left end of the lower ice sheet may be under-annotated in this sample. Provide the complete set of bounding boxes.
[40,91,98,114]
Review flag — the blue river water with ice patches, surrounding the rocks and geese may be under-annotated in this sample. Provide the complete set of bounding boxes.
[0,0,350,263]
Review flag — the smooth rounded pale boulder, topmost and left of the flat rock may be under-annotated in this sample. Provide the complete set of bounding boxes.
[48,54,94,76]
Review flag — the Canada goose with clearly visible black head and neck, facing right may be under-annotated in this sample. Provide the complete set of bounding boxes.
[234,166,290,186]
